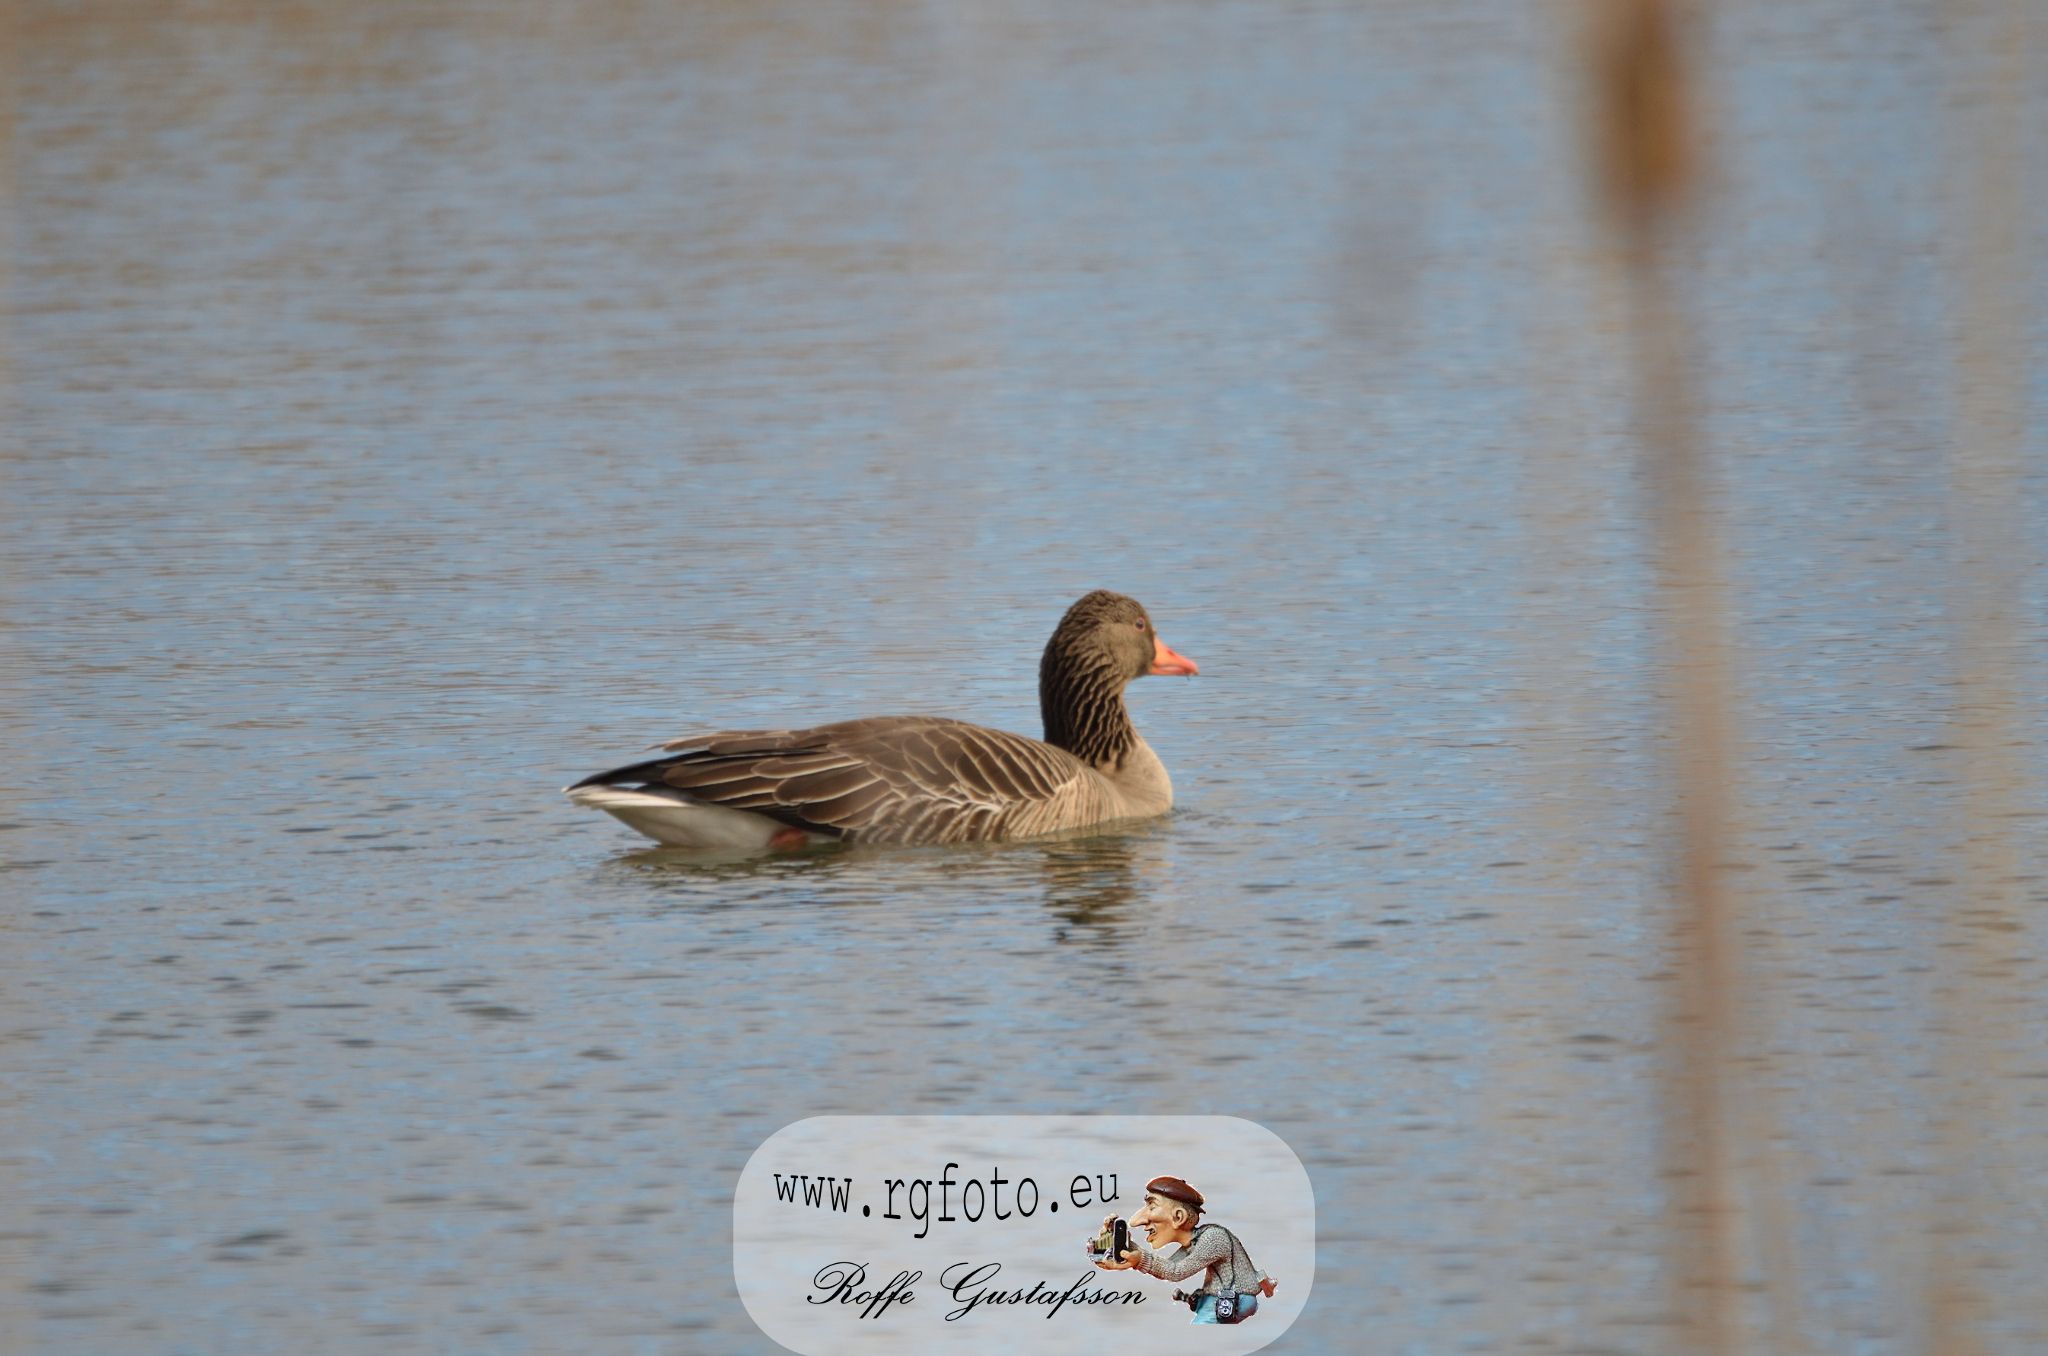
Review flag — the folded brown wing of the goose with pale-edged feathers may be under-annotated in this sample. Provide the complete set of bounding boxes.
[580,715,1090,844]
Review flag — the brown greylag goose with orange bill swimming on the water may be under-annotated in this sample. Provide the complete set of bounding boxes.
[567,590,1200,850]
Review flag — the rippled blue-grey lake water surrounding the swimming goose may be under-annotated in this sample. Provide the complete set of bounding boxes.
[0,2,2048,1354]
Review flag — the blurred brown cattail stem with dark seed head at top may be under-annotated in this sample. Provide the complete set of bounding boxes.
[1593,0,1741,1354]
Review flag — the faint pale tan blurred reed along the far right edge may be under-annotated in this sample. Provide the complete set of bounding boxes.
[1925,0,2034,1356]
